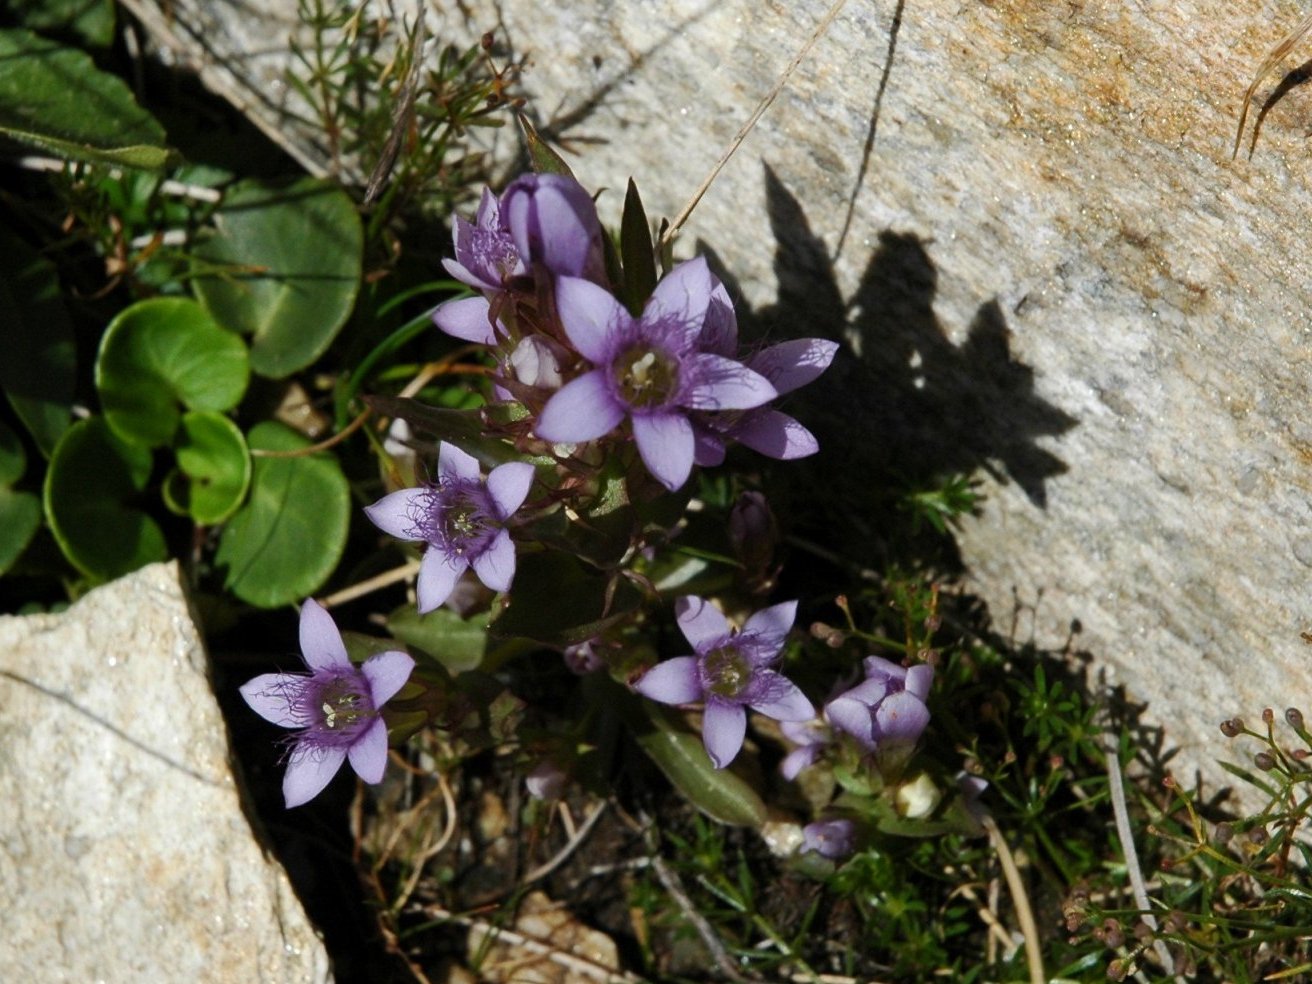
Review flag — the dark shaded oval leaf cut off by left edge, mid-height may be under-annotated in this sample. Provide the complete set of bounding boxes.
[0,226,76,458]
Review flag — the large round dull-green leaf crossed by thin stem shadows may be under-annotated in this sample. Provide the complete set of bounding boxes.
[193,178,363,379]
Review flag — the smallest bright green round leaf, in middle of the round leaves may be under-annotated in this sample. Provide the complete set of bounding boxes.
[164,411,252,526]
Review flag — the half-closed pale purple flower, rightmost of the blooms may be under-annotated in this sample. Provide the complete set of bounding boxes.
[825,656,934,750]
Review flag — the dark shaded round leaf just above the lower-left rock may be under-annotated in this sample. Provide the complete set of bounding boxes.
[45,417,168,581]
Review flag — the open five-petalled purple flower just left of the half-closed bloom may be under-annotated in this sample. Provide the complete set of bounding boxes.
[634,596,815,769]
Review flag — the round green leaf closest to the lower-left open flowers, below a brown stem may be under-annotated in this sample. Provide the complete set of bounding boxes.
[214,421,350,609]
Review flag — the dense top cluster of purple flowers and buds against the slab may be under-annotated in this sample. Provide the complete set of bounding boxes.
[433,174,837,491]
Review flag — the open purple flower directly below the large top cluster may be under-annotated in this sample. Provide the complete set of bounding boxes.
[365,441,533,613]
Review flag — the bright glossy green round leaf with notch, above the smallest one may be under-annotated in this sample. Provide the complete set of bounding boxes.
[96,298,251,447]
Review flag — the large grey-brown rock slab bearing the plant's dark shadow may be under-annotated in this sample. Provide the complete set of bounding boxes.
[125,0,1312,777]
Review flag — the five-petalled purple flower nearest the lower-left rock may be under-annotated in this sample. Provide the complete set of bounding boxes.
[241,600,415,808]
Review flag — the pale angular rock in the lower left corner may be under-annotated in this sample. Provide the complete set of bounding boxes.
[0,564,331,984]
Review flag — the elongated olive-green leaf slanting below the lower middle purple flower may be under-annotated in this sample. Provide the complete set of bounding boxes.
[631,701,766,828]
